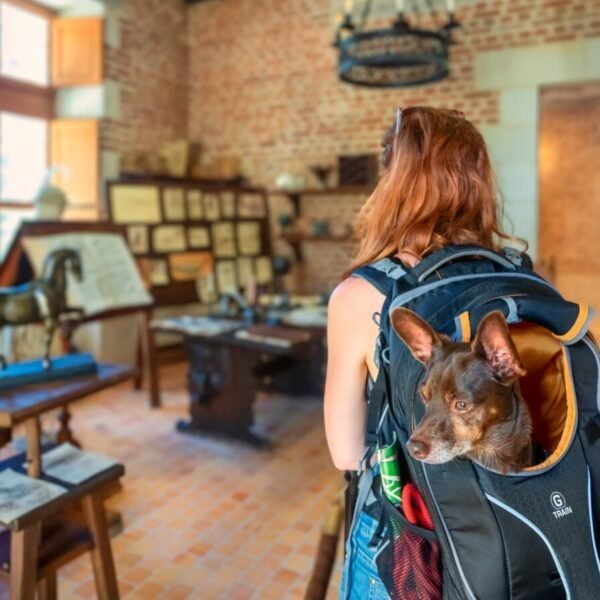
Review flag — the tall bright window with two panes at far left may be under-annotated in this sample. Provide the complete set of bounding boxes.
[0,0,53,259]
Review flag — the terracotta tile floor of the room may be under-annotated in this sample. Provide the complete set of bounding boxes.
[0,364,343,600]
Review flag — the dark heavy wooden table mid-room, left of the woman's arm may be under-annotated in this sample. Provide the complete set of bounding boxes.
[154,327,323,448]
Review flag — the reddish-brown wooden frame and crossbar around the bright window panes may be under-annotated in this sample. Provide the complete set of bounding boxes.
[0,0,56,210]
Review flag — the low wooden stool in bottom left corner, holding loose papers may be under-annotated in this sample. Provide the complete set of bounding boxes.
[0,454,124,600]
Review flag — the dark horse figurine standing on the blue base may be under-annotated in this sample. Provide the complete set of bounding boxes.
[0,248,83,371]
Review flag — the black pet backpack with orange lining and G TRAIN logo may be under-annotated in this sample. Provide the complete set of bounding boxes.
[354,245,600,600]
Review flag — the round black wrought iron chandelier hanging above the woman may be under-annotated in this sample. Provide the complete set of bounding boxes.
[334,0,460,88]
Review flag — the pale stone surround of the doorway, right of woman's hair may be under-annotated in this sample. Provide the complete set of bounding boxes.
[475,38,600,259]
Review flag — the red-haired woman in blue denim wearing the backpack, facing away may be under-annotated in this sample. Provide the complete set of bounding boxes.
[324,107,514,600]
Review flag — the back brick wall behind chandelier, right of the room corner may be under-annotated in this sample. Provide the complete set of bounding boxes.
[188,0,600,289]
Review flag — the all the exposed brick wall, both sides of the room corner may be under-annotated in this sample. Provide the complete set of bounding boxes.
[103,0,600,290]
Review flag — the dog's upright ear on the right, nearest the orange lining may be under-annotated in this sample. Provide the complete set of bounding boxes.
[471,310,526,383]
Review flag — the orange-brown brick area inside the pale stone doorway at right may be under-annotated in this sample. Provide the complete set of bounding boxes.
[539,83,600,308]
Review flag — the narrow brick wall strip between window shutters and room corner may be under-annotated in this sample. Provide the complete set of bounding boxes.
[102,0,188,152]
